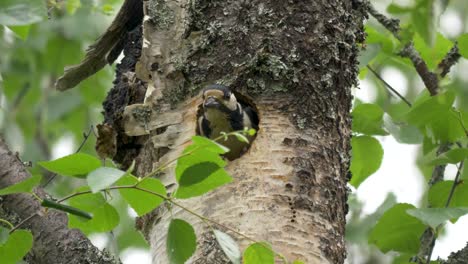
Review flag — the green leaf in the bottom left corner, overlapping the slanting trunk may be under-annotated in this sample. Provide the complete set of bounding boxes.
[0,229,33,264]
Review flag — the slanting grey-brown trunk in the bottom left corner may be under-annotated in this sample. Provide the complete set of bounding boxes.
[0,138,120,264]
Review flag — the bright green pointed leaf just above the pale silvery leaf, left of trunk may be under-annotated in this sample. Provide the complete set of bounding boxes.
[38,153,101,178]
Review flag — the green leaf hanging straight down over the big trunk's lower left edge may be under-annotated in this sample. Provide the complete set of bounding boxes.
[166,219,197,264]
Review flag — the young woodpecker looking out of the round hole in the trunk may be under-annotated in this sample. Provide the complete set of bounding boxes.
[198,84,258,160]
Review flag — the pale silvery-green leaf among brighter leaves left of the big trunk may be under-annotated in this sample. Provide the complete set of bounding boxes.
[86,167,127,193]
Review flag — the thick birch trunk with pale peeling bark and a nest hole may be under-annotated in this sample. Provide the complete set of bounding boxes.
[106,0,365,263]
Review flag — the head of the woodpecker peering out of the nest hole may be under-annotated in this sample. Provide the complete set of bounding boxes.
[203,84,237,113]
